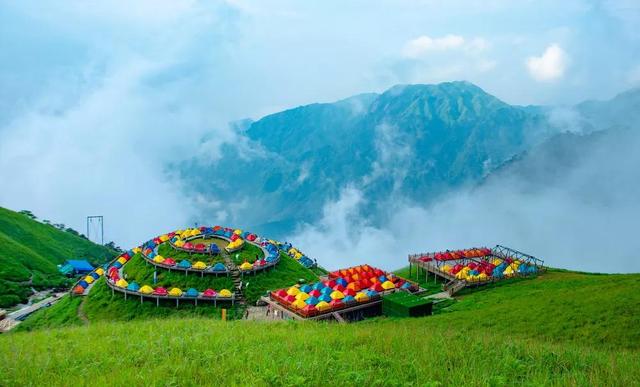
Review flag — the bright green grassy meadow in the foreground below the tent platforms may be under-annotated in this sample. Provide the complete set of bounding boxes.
[0,271,640,386]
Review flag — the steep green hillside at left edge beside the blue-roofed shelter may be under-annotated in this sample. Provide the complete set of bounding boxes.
[0,207,115,307]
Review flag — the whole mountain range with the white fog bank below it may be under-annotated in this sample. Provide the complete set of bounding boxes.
[182,82,640,272]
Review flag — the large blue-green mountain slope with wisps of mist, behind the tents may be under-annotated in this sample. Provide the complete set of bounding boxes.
[181,82,553,236]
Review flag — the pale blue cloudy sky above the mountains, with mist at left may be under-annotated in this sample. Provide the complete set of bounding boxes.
[0,0,640,249]
